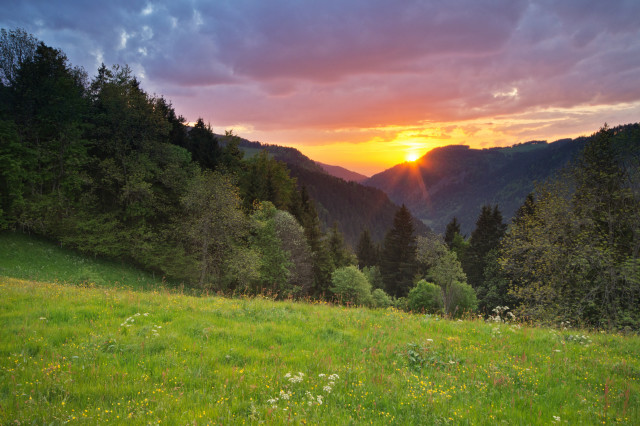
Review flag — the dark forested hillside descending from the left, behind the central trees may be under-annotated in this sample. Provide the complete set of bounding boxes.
[218,135,428,248]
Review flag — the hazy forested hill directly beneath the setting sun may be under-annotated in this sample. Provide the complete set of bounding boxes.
[364,123,640,235]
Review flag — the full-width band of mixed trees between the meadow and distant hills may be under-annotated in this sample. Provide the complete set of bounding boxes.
[0,30,640,330]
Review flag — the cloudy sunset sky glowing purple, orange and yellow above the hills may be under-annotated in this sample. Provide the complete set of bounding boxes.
[0,0,640,175]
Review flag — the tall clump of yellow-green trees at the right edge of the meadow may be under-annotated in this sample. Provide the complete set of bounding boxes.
[501,126,640,328]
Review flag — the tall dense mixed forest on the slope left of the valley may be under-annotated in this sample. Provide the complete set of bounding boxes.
[0,30,424,299]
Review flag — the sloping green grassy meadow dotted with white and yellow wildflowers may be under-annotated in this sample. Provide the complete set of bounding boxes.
[0,233,640,425]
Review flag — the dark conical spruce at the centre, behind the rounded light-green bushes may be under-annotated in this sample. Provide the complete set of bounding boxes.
[380,204,416,297]
